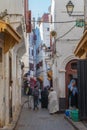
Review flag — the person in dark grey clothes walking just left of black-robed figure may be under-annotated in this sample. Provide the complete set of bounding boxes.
[33,86,39,110]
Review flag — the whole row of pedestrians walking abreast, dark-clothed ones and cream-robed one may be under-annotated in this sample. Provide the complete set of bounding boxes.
[27,86,58,114]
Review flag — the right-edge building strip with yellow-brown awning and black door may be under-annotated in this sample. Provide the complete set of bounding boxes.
[74,0,87,120]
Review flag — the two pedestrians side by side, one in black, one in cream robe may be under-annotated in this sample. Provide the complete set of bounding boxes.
[41,87,58,114]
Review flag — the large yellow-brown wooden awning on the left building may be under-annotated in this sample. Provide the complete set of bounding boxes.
[0,20,21,53]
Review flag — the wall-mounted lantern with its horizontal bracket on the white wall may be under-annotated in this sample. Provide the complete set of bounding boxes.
[66,1,84,16]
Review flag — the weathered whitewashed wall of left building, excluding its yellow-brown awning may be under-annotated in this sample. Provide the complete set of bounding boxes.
[0,0,26,125]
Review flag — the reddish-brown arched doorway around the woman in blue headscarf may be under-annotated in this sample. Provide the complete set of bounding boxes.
[65,59,78,108]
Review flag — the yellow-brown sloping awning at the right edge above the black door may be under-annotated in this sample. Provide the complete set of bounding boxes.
[74,30,87,57]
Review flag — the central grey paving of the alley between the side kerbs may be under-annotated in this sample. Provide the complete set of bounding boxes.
[15,101,74,130]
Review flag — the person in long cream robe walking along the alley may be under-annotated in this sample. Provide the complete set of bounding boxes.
[48,88,58,114]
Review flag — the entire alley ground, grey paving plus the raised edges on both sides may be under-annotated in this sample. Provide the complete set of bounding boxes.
[0,96,87,130]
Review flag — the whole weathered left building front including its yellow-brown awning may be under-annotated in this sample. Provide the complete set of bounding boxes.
[0,0,26,127]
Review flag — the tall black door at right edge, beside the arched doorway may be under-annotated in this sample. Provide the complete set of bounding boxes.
[78,59,87,120]
